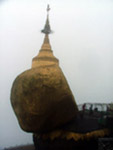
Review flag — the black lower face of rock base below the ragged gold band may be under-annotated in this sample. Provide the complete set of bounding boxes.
[33,137,113,150]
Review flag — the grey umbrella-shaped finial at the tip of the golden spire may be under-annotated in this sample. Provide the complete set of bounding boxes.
[41,4,52,34]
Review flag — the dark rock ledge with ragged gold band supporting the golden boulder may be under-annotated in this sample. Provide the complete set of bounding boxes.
[33,117,113,150]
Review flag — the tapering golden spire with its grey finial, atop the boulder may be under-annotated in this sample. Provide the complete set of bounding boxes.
[32,5,59,68]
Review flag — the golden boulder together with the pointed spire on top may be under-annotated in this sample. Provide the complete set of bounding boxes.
[11,5,78,134]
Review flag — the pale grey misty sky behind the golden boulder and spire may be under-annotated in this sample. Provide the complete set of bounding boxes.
[0,0,113,147]
